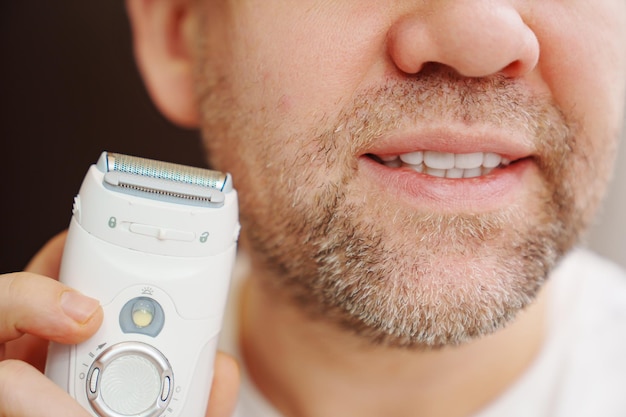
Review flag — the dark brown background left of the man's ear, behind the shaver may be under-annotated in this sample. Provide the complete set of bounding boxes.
[0,0,203,273]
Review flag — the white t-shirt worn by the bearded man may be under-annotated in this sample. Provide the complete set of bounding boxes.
[222,250,626,417]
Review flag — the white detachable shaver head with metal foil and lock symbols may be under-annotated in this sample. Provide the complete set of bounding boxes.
[72,152,239,257]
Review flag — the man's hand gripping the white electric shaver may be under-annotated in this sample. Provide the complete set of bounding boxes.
[0,233,239,417]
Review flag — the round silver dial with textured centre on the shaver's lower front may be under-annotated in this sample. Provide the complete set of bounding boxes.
[86,342,174,417]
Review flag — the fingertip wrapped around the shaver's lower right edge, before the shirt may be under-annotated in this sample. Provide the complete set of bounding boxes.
[206,352,240,417]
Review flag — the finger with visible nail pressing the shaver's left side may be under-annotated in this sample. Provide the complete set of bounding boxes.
[0,272,102,343]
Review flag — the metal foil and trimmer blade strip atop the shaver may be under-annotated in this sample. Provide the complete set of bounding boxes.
[96,152,233,206]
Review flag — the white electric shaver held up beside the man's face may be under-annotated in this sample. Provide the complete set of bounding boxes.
[46,152,239,417]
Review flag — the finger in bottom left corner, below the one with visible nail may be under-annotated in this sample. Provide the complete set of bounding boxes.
[0,360,90,417]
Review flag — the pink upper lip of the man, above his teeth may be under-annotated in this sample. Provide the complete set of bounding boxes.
[361,123,534,161]
